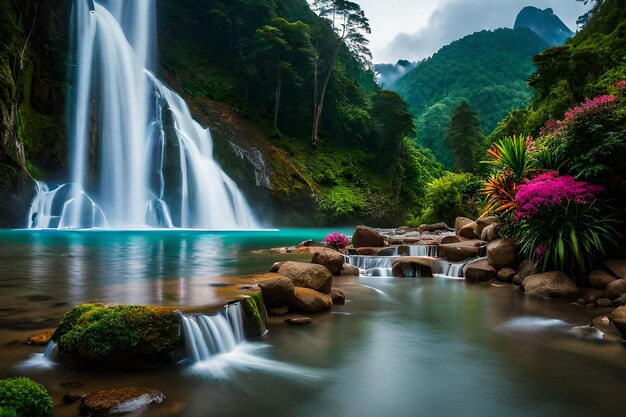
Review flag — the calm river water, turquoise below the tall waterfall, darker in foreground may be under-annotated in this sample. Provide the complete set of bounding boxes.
[0,229,626,417]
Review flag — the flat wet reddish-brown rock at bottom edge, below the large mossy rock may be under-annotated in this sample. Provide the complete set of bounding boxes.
[80,387,165,416]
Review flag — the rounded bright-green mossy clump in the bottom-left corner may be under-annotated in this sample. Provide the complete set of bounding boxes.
[0,377,52,417]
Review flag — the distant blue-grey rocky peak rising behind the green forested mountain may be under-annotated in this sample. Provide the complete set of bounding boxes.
[513,6,574,46]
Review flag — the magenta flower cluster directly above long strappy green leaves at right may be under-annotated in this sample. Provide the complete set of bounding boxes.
[515,171,604,220]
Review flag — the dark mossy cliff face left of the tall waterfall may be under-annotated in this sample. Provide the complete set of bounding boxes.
[0,0,70,227]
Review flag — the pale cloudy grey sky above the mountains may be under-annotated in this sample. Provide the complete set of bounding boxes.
[353,0,590,63]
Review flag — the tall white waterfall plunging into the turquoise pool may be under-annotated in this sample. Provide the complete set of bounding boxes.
[29,0,257,229]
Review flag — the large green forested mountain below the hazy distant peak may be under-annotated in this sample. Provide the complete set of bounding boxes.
[393,28,548,167]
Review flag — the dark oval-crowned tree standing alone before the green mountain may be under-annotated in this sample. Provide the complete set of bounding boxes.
[448,100,483,172]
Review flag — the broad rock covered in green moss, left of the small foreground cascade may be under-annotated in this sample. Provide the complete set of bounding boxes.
[52,304,181,366]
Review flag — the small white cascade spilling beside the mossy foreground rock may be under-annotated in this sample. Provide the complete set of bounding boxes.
[178,303,245,362]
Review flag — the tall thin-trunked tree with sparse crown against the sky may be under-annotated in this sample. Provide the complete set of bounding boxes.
[311,0,372,146]
